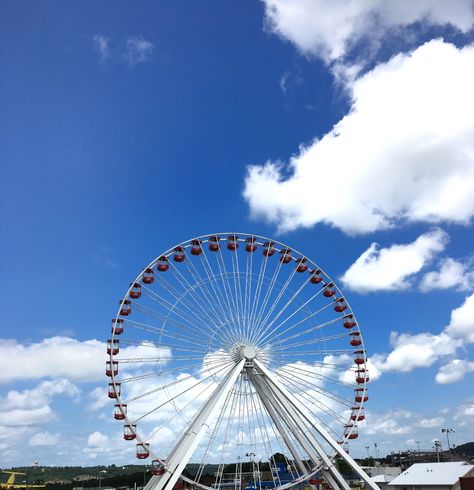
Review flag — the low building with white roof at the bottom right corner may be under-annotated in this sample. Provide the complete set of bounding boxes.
[387,461,474,490]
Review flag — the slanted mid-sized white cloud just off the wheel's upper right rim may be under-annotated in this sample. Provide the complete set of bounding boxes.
[341,230,448,292]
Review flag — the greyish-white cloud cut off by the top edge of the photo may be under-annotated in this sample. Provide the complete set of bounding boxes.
[264,0,474,62]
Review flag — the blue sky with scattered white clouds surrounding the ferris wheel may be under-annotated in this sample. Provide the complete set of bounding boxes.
[0,0,474,466]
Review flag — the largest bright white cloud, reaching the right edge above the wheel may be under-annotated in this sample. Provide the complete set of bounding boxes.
[244,39,474,234]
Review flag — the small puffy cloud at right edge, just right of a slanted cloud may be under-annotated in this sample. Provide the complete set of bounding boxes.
[420,257,474,291]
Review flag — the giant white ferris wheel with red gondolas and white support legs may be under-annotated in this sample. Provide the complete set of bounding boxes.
[106,233,378,490]
